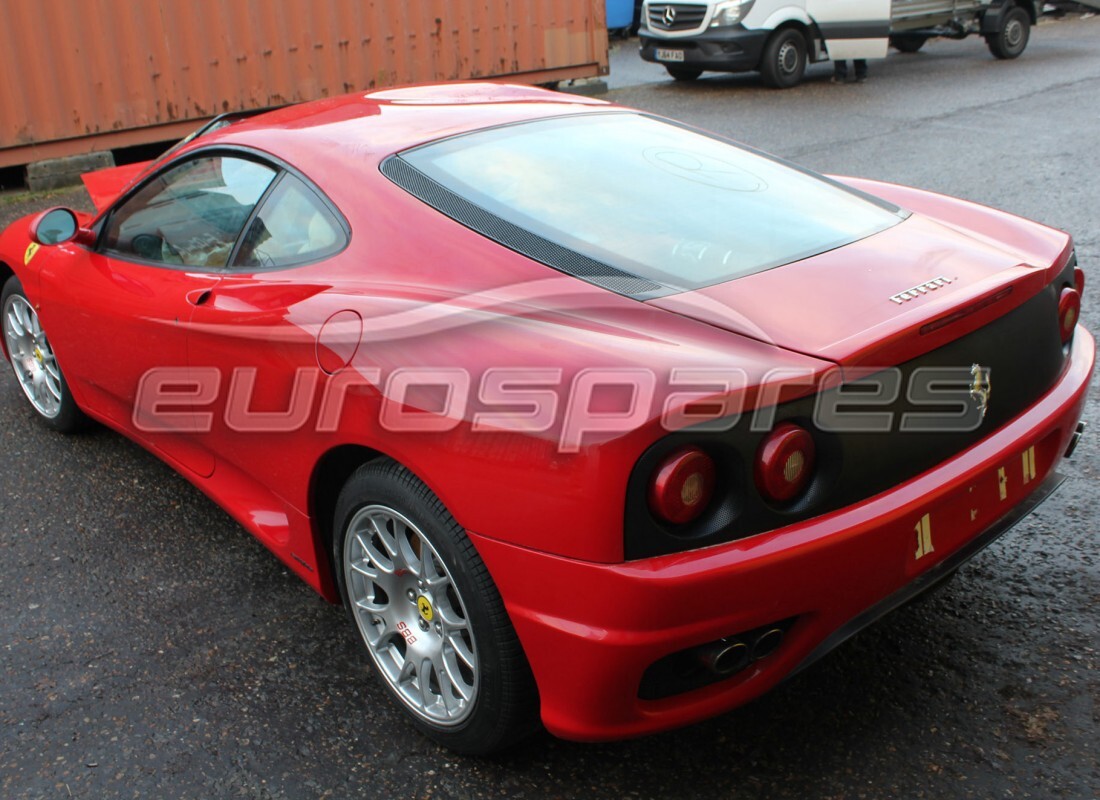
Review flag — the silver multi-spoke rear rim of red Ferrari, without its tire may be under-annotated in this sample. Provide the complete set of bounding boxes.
[343,505,480,726]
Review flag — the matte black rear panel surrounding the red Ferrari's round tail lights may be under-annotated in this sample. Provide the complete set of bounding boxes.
[624,275,1073,559]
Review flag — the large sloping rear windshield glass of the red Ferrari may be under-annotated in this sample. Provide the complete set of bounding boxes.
[400,113,905,291]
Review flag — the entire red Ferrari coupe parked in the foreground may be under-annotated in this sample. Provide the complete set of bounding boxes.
[0,85,1095,753]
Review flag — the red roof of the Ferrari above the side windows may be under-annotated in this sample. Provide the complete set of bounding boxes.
[188,83,616,173]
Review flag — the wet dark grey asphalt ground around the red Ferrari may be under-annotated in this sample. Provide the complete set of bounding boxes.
[0,18,1100,800]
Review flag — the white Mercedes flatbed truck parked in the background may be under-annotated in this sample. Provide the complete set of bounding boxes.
[638,0,1042,88]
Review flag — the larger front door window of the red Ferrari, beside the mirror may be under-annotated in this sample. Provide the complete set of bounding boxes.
[103,155,277,269]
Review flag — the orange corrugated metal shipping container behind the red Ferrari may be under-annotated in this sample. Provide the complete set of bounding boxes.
[0,0,607,167]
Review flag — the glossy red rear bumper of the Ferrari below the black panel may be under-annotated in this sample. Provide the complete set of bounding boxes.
[471,329,1096,741]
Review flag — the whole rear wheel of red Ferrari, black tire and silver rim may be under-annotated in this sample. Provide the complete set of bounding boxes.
[333,459,539,755]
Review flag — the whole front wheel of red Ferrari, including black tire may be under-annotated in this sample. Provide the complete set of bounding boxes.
[0,276,88,434]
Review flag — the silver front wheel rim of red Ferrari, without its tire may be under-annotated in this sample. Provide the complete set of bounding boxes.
[3,294,62,419]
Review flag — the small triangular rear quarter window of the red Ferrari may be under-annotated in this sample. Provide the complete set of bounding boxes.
[233,173,348,267]
